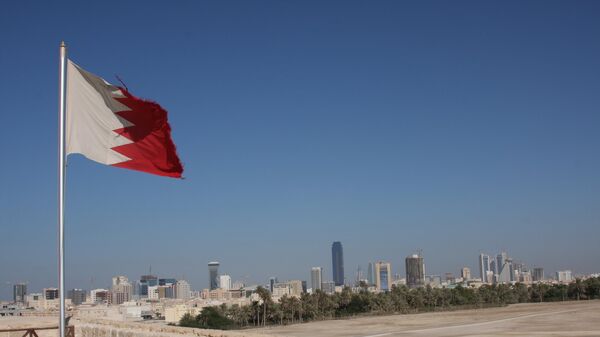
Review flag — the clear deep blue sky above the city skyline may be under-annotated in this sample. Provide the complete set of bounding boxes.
[0,1,600,298]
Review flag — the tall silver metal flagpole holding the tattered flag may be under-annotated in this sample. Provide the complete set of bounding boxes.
[58,41,67,337]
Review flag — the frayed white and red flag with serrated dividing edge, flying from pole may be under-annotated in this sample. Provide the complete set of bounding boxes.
[65,60,183,178]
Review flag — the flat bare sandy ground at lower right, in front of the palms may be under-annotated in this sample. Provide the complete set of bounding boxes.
[256,301,600,337]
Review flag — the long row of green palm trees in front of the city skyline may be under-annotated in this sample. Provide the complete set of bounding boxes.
[180,277,600,329]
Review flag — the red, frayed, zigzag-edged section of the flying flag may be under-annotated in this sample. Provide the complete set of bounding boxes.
[112,88,183,178]
